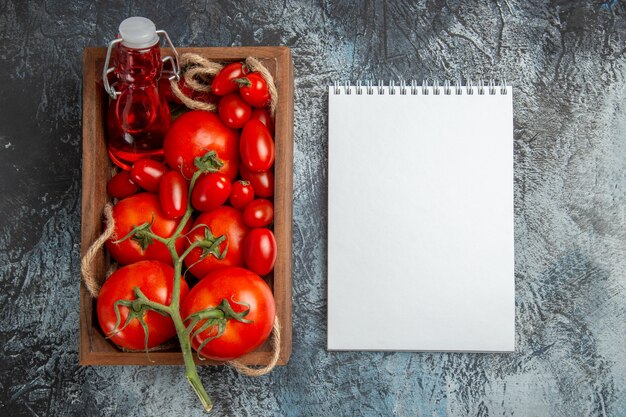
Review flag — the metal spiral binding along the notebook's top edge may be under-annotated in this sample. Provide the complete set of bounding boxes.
[332,78,508,96]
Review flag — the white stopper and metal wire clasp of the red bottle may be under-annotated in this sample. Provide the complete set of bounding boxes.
[102,17,180,100]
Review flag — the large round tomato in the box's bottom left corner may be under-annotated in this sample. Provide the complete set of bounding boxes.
[96,261,189,350]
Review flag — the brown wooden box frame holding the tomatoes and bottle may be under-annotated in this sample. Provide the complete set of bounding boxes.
[79,47,293,365]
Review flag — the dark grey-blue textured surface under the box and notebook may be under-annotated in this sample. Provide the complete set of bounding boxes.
[0,0,626,417]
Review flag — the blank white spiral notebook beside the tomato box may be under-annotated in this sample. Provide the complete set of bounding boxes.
[328,79,515,352]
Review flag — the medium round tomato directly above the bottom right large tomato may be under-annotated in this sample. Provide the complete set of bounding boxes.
[185,206,249,278]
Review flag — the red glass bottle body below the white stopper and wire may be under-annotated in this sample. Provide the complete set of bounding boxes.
[108,42,171,169]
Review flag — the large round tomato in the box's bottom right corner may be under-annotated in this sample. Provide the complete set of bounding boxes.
[182,268,276,361]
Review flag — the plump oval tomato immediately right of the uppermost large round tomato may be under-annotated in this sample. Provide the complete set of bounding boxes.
[239,120,274,172]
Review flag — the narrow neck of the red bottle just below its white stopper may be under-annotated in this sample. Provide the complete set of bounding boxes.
[115,43,162,85]
